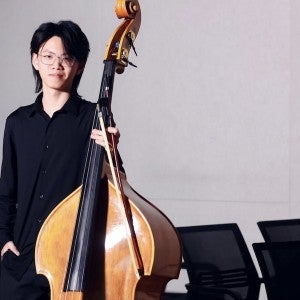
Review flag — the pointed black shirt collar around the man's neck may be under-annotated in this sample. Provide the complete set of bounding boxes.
[29,93,81,117]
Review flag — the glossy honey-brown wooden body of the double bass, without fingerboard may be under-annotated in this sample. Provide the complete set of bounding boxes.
[35,169,182,300]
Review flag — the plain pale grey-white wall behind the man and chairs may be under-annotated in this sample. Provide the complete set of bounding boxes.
[0,0,300,298]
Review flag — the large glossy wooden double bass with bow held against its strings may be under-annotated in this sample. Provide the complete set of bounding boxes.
[35,0,182,300]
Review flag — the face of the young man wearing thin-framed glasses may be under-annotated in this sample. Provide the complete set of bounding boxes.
[32,36,83,92]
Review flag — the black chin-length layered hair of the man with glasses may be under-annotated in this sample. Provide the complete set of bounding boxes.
[30,21,90,94]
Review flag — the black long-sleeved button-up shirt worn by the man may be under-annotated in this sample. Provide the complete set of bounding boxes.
[0,94,95,278]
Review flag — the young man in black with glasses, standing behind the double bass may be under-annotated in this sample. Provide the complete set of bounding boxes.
[0,21,119,300]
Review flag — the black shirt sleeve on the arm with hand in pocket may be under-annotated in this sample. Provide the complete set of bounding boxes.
[0,118,17,250]
